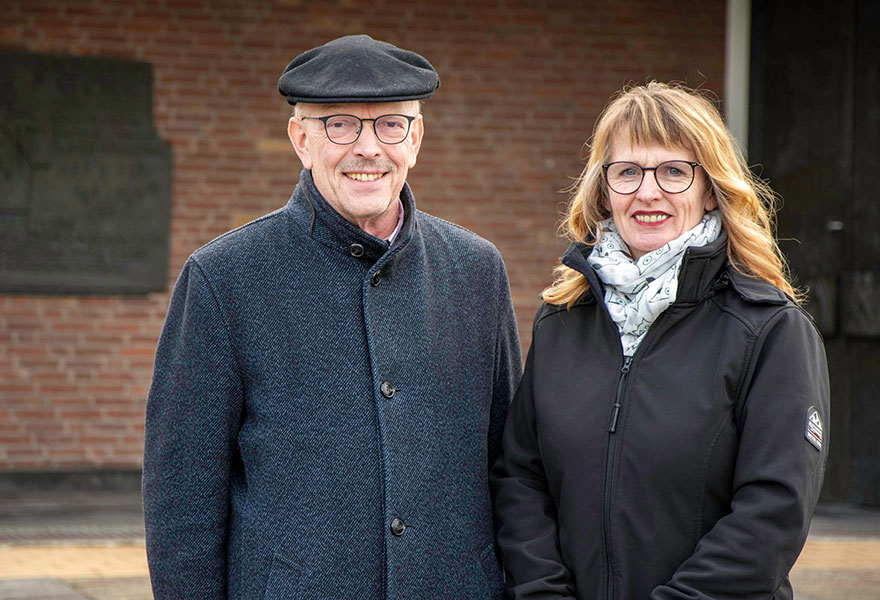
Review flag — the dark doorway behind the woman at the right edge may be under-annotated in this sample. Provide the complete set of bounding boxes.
[748,0,880,505]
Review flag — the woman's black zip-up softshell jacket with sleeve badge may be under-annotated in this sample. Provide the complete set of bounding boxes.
[491,234,829,600]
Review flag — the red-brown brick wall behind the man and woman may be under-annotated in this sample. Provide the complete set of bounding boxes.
[0,0,725,471]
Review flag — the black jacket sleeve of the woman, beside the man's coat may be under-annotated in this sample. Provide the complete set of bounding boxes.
[489,313,575,600]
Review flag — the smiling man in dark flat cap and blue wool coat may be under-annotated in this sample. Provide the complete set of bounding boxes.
[143,35,521,600]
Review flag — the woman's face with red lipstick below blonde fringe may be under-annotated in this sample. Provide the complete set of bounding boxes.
[605,133,717,260]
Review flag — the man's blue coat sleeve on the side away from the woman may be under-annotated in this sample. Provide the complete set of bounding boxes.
[143,258,242,600]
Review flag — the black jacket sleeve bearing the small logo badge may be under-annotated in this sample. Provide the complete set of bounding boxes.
[650,307,830,600]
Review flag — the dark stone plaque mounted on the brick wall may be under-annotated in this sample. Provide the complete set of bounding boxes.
[0,52,172,294]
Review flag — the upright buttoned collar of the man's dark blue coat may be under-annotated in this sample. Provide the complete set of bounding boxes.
[285,169,416,262]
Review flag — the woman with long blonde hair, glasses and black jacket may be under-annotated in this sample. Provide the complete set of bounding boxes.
[490,82,829,600]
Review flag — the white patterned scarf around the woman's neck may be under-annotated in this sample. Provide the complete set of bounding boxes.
[587,210,721,356]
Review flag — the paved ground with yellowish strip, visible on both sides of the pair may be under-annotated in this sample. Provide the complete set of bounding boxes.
[0,491,880,600]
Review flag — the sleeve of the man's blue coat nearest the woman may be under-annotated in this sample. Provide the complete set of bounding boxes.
[487,258,522,468]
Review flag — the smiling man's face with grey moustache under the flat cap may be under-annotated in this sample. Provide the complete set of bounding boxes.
[287,101,424,237]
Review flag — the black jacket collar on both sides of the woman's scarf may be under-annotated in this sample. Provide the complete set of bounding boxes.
[562,229,727,304]
